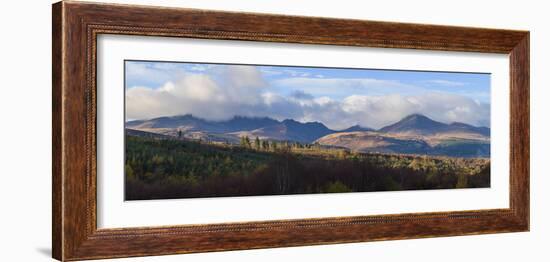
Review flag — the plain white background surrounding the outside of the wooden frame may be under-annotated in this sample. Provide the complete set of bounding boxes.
[0,0,550,262]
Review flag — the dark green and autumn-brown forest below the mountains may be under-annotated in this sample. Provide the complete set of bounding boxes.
[125,135,491,200]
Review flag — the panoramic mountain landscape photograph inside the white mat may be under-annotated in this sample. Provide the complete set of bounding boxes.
[124,60,491,201]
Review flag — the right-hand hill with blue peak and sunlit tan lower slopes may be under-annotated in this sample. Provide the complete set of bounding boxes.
[315,114,490,157]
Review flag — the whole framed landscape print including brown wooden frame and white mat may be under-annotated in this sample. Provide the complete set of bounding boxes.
[52,1,529,261]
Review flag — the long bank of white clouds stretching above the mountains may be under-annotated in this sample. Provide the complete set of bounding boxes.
[126,66,490,129]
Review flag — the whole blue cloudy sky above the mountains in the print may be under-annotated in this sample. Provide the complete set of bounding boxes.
[125,61,491,130]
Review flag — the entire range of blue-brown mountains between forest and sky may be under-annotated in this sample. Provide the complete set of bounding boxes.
[126,114,491,157]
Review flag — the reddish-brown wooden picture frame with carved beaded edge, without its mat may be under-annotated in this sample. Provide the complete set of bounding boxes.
[52,1,529,261]
